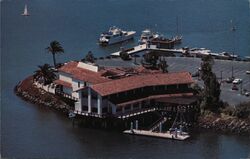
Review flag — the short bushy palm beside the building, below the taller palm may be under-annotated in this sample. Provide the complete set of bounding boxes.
[33,64,56,85]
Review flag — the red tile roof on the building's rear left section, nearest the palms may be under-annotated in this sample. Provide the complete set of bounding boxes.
[59,61,109,84]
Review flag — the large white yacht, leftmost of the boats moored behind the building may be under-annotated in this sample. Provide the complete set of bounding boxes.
[99,26,136,46]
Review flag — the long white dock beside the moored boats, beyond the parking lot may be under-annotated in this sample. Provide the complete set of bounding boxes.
[111,44,183,56]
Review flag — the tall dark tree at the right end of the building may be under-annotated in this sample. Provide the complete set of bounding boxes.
[201,55,221,112]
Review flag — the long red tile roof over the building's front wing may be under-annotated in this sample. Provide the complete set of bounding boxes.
[91,72,193,96]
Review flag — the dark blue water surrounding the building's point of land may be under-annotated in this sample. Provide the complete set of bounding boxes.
[1,0,250,158]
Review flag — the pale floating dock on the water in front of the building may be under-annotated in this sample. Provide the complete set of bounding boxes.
[123,129,190,141]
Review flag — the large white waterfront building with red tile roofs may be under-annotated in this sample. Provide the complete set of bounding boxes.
[55,61,194,117]
